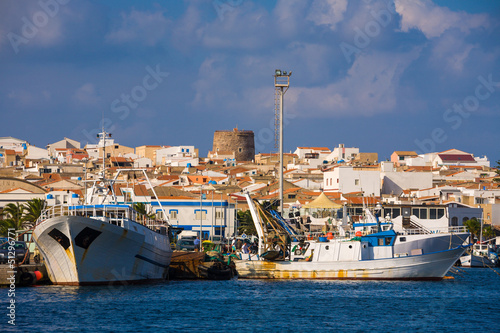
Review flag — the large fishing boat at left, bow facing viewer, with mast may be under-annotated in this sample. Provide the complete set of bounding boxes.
[33,131,172,285]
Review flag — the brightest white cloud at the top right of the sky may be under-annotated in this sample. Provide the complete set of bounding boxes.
[395,0,488,38]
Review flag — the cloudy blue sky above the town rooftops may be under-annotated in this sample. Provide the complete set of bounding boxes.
[0,0,500,161]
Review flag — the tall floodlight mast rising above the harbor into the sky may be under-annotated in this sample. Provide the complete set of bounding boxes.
[274,69,292,216]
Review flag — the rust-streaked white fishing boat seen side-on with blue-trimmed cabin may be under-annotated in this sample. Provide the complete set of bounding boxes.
[236,194,466,280]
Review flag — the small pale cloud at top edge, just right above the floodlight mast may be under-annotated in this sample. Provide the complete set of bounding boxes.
[307,0,347,30]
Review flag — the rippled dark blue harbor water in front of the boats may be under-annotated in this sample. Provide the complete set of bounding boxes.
[4,269,500,332]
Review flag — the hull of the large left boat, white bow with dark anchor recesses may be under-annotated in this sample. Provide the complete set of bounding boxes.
[33,216,172,285]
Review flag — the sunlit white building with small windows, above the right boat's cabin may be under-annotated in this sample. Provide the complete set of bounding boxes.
[323,166,380,197]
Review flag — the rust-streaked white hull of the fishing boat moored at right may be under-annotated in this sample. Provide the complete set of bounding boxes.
[236,247,465,280]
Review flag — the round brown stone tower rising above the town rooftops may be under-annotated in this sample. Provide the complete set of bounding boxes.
[213,128,255,161]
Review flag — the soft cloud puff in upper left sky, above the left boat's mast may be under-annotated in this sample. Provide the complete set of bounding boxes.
[106,9,170,46]
